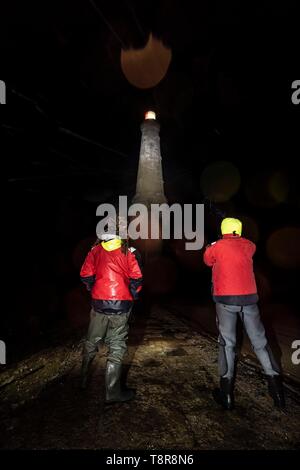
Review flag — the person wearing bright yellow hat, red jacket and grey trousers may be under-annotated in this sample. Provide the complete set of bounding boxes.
[204,218,284,409]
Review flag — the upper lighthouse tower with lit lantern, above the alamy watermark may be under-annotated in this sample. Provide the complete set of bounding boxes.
[133,111,167,206]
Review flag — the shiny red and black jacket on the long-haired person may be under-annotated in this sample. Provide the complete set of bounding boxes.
[80,242,142,313]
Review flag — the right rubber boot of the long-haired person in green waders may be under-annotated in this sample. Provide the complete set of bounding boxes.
[105,361,135,403]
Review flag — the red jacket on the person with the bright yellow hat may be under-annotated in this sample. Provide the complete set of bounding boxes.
[204,234,258,305]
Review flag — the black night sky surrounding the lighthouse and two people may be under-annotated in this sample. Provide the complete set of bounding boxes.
[0,0,300,358]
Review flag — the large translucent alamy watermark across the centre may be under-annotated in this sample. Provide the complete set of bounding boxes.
[96,196,204,250]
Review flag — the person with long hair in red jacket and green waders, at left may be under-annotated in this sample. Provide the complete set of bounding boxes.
[80,225,142,403]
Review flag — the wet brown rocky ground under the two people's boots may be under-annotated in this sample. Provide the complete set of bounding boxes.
[0,306,300,450]
